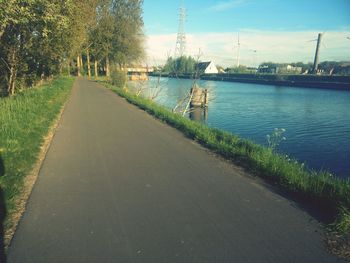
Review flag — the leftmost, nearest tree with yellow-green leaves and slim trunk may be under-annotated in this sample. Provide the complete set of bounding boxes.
[0,0,71,95]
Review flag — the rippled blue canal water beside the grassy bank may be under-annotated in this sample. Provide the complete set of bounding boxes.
[129,77,350,178]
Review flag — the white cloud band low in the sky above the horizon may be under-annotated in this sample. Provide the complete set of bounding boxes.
[146,29,350,66]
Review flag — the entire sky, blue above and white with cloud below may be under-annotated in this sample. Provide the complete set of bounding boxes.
[143,0,350,67]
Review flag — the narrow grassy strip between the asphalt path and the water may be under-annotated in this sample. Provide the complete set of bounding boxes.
[103,82,350,234]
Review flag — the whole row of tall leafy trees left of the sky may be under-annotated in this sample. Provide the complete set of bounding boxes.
[0,0,144,95]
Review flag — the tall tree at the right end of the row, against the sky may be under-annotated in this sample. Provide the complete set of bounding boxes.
[91,0,144,76]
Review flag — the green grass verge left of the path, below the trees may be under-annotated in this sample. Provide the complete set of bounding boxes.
[0,77,74,233]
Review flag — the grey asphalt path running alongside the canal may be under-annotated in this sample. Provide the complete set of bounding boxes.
[8,79,339,263]
